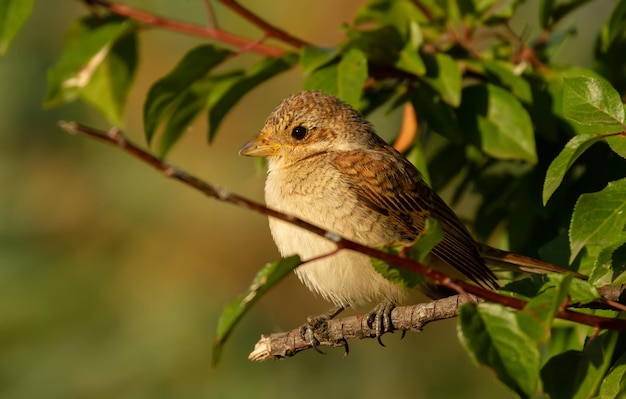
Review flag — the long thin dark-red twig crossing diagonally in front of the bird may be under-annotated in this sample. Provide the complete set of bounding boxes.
[59,122,626,331]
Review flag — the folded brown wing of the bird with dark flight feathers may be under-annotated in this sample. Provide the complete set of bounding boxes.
[332,146,498,289]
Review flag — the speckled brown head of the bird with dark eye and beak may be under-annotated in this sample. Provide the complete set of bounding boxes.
[239,91,381,166]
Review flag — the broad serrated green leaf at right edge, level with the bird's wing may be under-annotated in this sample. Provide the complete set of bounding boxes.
[569,178,626,263]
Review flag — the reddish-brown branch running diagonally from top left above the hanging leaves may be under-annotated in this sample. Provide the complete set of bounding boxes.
[82,0,285,57]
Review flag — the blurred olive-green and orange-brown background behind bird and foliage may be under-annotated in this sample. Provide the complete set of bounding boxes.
[0,0,614,399]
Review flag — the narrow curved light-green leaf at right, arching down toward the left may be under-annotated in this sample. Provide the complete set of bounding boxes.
[542,134,602,205]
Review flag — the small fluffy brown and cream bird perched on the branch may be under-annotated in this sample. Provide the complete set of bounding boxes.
[239,91,580,336]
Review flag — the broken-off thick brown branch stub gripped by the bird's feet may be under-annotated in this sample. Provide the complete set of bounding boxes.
[248,295,472,362]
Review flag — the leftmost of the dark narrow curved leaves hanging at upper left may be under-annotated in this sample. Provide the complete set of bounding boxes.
[143,44,232,148]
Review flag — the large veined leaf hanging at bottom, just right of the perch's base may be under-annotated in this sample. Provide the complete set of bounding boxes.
[458,303,540,398]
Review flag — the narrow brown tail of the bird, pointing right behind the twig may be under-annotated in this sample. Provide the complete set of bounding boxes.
[477,243,588,280]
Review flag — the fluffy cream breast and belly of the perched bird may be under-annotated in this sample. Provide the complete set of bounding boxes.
[265,161,405,306]
